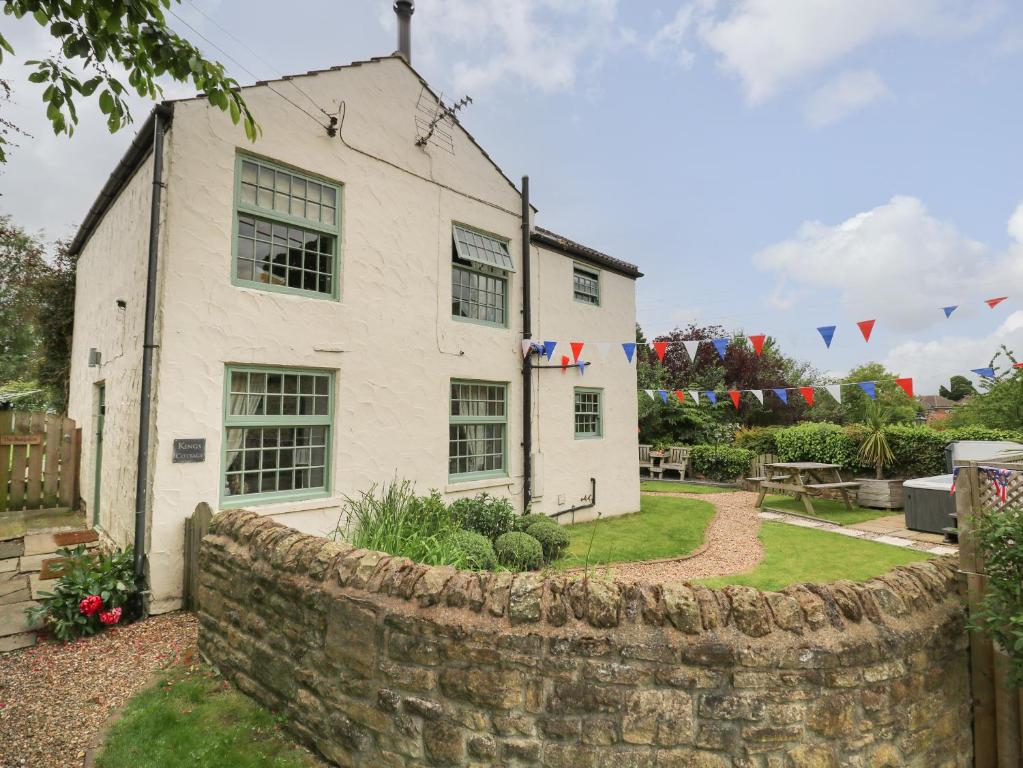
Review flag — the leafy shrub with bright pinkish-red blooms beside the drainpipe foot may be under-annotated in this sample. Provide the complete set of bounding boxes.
[28,546,135,641]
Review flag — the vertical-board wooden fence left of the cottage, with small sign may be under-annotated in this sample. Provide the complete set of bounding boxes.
[0,411,82,512]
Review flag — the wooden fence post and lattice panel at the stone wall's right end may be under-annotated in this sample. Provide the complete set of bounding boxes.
[955,461,1023,768]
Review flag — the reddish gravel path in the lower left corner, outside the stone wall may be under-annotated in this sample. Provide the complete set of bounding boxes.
[0,612,196,768]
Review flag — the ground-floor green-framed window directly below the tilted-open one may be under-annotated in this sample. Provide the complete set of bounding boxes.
[448,381,507,480]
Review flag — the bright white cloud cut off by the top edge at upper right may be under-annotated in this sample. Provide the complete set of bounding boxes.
[655,0,1000,104]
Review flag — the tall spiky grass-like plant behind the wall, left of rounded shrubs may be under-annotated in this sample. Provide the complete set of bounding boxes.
[335,480,461,566]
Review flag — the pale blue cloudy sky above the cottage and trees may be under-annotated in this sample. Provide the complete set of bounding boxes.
[0,0,1023,394]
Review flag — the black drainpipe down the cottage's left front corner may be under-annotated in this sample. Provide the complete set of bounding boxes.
[135,104,171,593]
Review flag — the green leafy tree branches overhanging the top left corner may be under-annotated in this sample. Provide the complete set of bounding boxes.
[0,0,260,163]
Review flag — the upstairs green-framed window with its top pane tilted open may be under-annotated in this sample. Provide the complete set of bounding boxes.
[451,224,514,326]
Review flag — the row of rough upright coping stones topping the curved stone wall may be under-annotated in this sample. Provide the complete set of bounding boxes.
[210,509,959,637]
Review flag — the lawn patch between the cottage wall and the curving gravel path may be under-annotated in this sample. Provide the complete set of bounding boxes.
[557,496,714,568]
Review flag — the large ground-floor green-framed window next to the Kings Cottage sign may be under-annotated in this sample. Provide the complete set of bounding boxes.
[223,367,333,501]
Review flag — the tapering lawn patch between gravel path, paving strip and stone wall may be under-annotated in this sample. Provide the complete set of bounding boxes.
[701,521,928,590]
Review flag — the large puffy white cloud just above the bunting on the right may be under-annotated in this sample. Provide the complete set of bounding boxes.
[753,196,1023,331]
